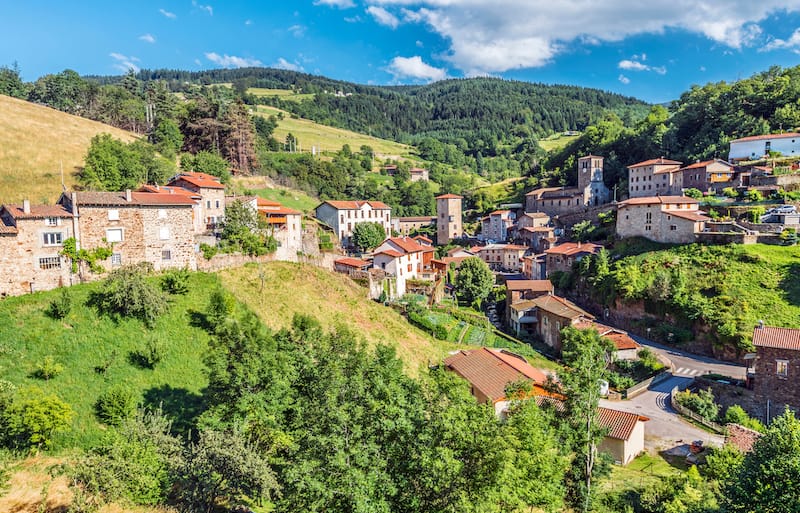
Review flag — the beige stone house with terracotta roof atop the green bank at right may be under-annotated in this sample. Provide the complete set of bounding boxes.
[617,196,711,244]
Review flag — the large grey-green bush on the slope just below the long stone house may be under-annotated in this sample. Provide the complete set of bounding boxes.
[91,264,167,327]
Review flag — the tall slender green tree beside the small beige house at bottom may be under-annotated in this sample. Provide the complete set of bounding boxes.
[559,326,611,512]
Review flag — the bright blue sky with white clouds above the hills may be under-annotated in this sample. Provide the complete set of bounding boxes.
[0,0,800,102]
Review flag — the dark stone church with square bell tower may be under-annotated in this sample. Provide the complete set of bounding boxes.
[525,155,611,216]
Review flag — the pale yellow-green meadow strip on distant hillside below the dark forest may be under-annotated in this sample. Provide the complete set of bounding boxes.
[257,105,411,158]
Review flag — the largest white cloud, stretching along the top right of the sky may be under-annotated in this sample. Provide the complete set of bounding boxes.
[368,0,800,74]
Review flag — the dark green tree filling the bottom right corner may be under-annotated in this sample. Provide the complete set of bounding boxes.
[722,410,800,513]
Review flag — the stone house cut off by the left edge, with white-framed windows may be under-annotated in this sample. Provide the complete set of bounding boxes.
[0,200,75,297]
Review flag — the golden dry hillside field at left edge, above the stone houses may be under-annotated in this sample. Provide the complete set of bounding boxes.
[0,95,135,203]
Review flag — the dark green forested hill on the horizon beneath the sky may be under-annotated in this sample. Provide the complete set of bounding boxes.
[88,68,648,157]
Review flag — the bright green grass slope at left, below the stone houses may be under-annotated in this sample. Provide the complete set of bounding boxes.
[0,273,218,448]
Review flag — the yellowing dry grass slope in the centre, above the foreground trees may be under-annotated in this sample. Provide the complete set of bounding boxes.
[219,262,451,376]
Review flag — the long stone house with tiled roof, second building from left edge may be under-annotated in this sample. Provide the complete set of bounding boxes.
[58,190,197,270]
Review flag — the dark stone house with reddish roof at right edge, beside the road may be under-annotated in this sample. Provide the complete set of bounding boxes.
[752,324,800,417]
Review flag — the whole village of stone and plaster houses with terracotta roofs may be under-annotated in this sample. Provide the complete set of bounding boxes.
[0,130,800,464]
